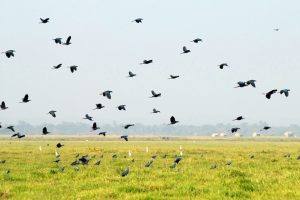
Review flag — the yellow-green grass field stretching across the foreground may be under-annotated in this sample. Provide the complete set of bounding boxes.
[0,139,300,200]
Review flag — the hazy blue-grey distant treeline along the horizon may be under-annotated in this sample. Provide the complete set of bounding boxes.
[0,121,300,136]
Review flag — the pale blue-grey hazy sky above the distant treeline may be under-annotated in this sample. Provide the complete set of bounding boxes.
[0,0,300,126]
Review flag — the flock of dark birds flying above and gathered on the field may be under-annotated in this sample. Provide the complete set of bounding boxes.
[0,18,290,176]
